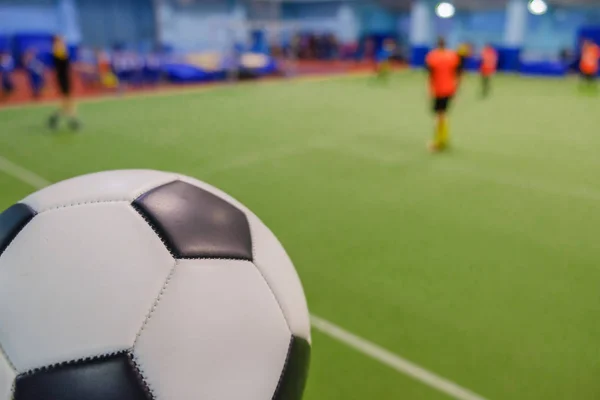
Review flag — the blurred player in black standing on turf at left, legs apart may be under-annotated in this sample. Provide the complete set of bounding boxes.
[48,36,81,130]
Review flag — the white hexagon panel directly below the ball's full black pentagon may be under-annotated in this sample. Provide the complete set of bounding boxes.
[134,260,291,400]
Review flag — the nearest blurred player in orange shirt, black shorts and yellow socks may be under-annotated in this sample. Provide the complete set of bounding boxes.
[425,38,464,152]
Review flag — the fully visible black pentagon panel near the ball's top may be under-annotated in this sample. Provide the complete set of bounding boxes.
[133,181,252,260]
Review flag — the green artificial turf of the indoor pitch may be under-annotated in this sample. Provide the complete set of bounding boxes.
[0,72,600,400]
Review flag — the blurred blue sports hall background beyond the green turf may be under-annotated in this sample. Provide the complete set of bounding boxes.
[0,0,600,100]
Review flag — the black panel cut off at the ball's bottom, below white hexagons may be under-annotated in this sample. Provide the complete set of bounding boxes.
[13,352,153,400]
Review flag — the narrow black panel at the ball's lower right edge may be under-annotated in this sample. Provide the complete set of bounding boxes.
[273,336,311,400]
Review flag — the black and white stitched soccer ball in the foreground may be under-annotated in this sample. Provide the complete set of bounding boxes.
[0,170,310,400]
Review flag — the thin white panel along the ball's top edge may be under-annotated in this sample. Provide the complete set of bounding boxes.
[23,170,177,212]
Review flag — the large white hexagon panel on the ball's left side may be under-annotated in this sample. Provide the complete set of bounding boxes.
[0,202,175,372]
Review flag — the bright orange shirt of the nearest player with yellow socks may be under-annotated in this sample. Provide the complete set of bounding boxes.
[425,49,460,97]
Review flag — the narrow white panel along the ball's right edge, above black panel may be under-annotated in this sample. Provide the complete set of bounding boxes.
[247,213,310,342]
